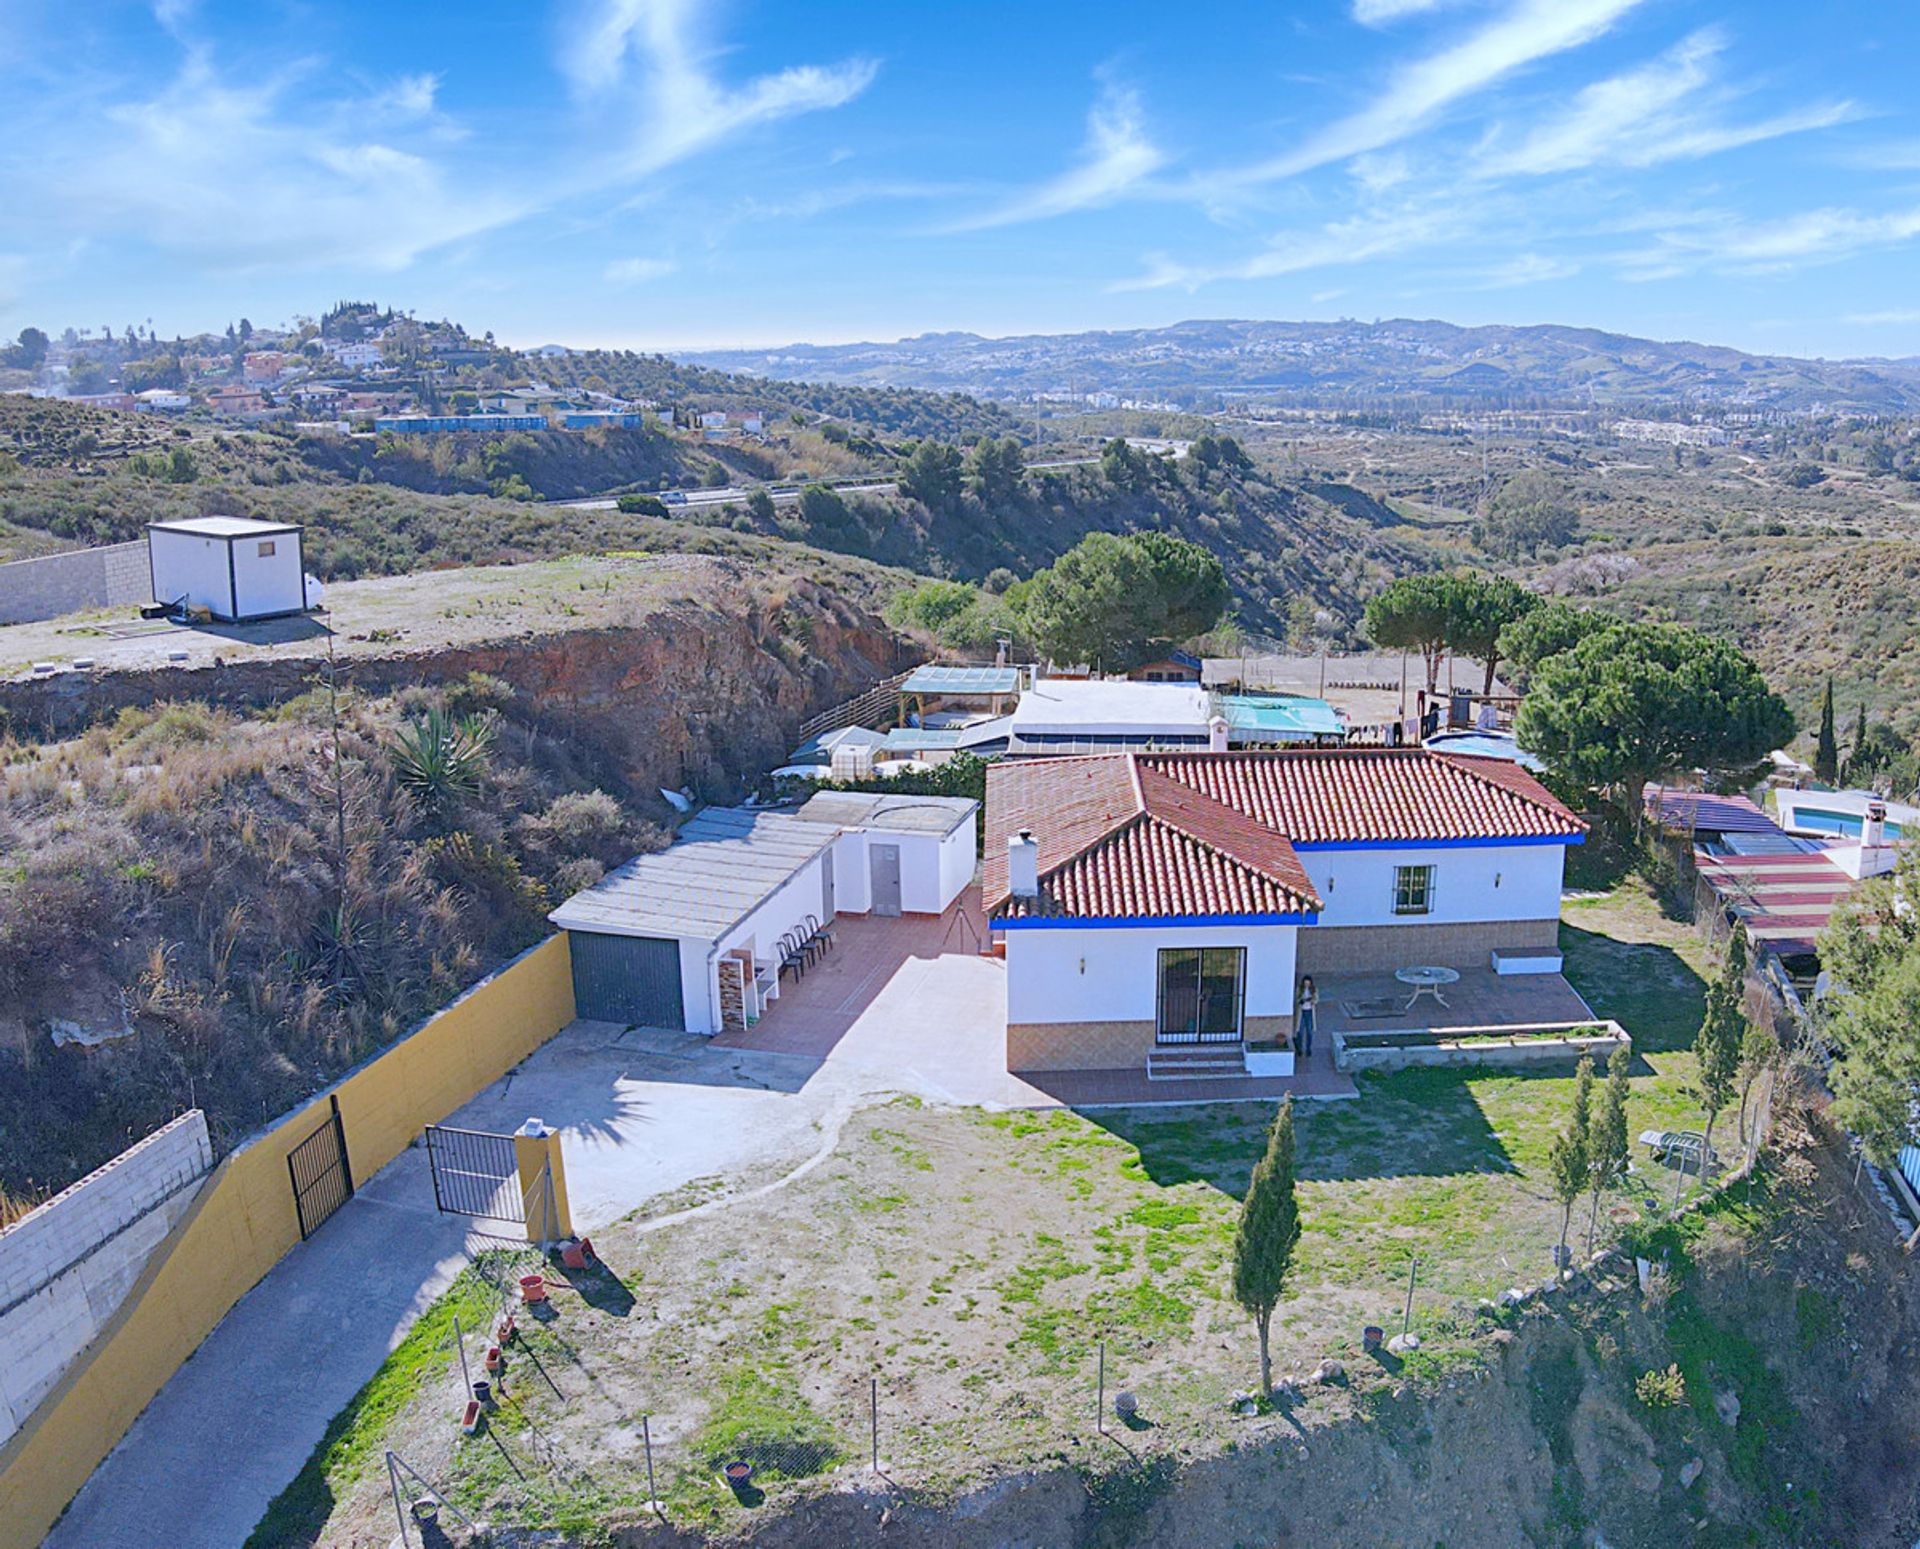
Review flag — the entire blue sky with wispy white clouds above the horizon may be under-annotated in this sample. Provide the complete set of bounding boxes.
[0,0,1920,355]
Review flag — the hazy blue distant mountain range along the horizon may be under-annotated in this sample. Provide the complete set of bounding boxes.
[684,319,1920,413]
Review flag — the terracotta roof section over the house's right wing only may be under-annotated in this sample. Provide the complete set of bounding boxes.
[1140,749,1586,845]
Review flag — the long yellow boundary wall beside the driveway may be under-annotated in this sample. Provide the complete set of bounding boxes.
[0,935,574,1549]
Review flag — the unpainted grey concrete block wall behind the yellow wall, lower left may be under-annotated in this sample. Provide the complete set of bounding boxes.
[0,1109,213,1443]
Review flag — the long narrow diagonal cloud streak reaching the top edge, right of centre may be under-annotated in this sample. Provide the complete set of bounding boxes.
[1215,0,1644,186]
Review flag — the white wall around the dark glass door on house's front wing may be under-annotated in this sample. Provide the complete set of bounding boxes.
[1006,925,1298,1023]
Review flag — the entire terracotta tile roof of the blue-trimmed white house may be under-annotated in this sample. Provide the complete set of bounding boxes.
[981,749,1584,919]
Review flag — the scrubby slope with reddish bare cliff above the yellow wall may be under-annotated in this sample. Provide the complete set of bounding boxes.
[0,560,891,1196]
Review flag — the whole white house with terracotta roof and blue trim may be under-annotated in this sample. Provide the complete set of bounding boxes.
[983,749,1586,1071]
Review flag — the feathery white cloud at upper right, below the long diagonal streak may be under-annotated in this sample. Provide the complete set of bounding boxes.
[1476,27,1857,177]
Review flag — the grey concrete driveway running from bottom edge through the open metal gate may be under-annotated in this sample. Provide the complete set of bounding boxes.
[46,1023,893,1549]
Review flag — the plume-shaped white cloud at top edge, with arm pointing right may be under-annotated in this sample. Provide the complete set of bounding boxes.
[561,0,879,175]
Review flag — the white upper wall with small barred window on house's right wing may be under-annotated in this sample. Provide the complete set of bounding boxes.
[1300,845,1567,925]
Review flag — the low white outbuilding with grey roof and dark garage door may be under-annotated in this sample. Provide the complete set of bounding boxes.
[547,791,979,1035]
